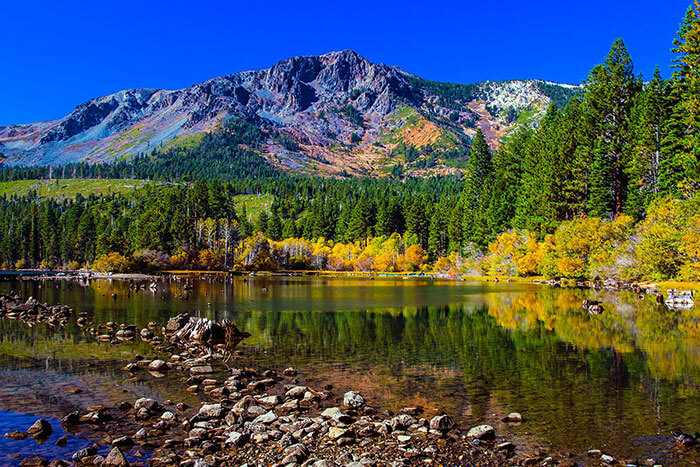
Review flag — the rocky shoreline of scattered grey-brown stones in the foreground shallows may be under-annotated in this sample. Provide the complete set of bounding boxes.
[0,294,660,466]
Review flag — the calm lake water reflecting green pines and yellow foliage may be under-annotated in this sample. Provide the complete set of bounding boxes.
[0,277,700,465]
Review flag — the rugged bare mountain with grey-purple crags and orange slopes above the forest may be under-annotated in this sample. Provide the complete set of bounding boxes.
[0,50,579,175]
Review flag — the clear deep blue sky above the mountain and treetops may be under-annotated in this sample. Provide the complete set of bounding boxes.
[0,0,690,125]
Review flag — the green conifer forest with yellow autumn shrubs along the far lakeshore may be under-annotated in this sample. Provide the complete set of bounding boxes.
[0,1,700,279]
